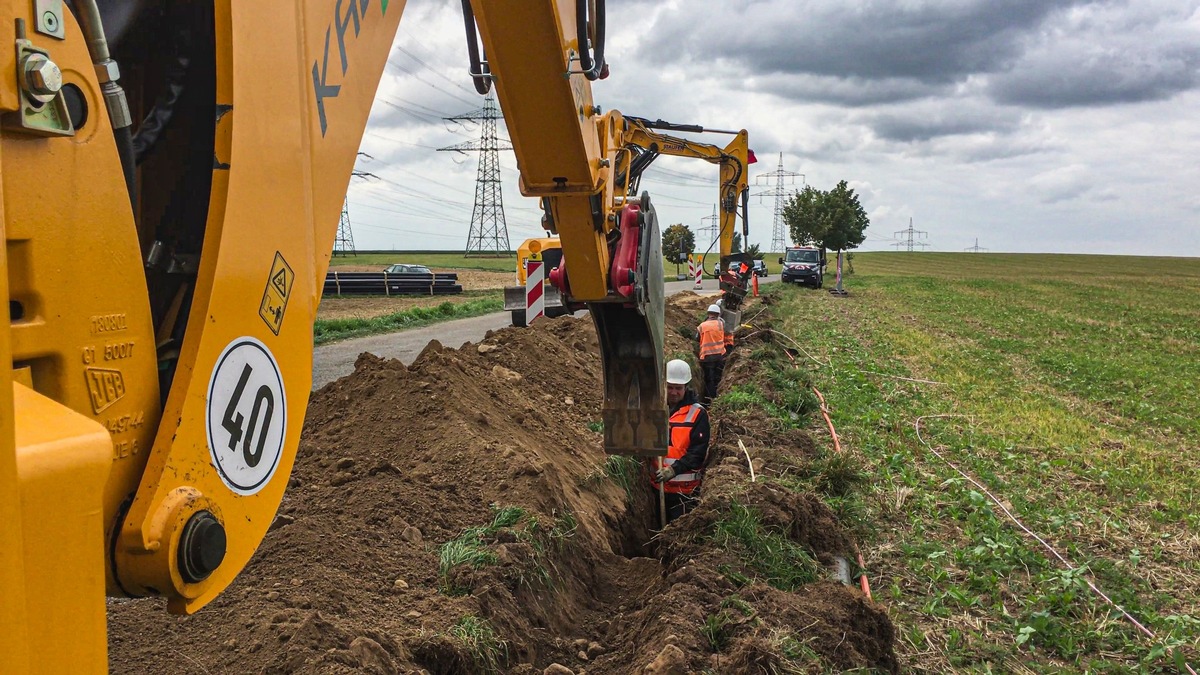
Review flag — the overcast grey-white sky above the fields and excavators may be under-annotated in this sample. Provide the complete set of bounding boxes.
[349,0,1200,256]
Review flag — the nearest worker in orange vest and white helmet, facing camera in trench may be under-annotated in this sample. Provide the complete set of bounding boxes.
[650,359,709,522]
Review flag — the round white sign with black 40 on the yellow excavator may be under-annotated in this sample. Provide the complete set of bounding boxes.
[206,336,288,495]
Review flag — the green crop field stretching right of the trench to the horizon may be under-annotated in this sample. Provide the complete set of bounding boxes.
[770,253,1200,673]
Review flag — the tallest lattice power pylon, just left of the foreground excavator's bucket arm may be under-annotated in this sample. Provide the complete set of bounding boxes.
[438,95,512,256]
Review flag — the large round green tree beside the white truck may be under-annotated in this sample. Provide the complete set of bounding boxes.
[784,180,871,251]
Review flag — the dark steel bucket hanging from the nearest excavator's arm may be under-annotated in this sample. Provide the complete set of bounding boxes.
[588,195,670,456]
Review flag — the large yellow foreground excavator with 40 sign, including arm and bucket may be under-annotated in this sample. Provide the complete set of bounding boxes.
[0,0,667,673]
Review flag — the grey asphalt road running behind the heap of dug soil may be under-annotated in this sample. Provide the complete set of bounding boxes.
[312,274,779,389]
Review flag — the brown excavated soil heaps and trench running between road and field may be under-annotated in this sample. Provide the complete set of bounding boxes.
[109,295,899,675]
